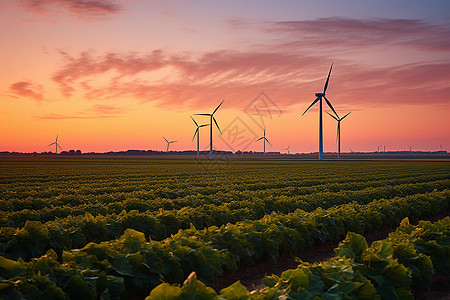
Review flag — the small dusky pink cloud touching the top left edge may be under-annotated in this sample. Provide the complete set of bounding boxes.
[19,0,122,19]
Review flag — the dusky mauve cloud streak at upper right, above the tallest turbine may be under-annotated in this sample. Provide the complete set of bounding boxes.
[264,18,450,51]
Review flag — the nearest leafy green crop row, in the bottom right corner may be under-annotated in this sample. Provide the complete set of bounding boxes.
[146,217,450,300]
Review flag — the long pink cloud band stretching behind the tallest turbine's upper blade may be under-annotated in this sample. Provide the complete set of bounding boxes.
[49,50,450,108]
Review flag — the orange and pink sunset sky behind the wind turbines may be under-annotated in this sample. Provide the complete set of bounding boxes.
[0,0,450,153]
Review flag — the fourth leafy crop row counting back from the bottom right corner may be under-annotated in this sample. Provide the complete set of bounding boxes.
[0,173,450,227]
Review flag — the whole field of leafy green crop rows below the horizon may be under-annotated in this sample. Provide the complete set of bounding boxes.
[0,158,450,299]
